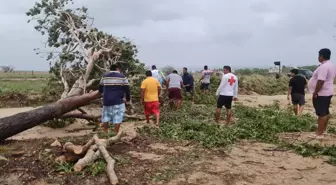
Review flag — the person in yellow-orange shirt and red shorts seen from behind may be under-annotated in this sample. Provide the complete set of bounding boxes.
[141,71,161,128]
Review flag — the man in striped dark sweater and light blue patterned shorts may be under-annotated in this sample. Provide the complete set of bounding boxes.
[99,64,131,134]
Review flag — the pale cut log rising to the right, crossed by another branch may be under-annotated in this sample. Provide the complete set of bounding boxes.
[74,131,124,172]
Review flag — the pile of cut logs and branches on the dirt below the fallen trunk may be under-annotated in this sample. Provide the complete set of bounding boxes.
[52,132,124,185]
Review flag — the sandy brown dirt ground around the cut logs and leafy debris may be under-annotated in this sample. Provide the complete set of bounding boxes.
[0,95,336,185]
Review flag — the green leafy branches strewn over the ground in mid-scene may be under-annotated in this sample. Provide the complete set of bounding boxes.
[140,103,336,164]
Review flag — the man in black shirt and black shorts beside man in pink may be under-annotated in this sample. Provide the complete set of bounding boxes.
[287,69,307,117]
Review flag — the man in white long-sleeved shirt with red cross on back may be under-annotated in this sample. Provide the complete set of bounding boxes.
[216,66,238,124]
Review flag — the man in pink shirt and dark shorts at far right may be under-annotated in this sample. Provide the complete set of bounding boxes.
[308,48,336,139]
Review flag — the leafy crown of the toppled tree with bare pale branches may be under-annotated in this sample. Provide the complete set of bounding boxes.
[27,0,145,99]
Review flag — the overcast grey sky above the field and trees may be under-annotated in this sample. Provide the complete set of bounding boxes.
[0,0,336,70]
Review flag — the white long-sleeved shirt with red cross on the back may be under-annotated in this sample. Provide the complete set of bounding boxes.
[216,73,238,97]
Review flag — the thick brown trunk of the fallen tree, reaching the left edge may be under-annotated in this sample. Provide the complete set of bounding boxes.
[0,91,100,141]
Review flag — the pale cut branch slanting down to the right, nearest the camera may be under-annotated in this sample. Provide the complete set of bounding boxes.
[93,135,119,185]
